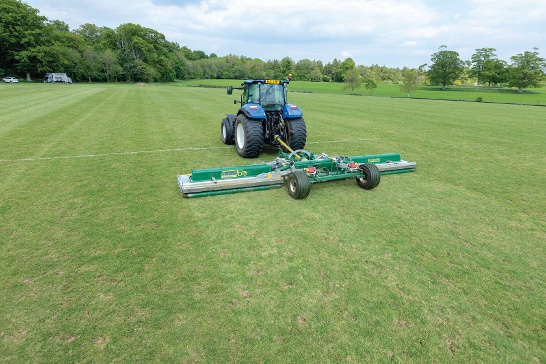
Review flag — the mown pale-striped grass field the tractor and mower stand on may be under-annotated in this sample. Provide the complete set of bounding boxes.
[0,84,546,363]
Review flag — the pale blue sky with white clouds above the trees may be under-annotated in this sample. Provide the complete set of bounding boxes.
[22,0,546,68]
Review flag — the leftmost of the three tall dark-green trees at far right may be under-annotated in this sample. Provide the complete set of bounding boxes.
[428,45,464,89]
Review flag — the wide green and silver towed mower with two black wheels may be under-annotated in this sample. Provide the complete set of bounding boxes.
[178,136,416,199]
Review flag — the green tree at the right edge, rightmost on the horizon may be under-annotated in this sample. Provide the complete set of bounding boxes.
[508,48,546,92]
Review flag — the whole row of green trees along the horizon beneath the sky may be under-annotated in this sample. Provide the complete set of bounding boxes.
[0,0,546,91]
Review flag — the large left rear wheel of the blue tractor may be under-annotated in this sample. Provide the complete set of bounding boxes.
[235,114,264,158]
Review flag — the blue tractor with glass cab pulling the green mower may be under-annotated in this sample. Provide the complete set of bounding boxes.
[221,79,307,158]
